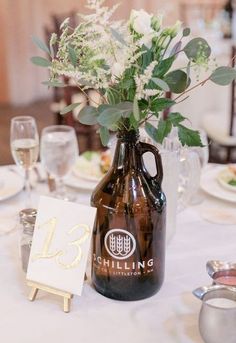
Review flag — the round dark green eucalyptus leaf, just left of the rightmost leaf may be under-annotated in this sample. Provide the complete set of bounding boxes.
[165,70,190,94]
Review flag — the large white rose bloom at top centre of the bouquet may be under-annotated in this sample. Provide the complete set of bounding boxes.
[130,9,153,35]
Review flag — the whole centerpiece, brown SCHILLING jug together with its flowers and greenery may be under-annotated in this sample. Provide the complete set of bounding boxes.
[32,0,236,300]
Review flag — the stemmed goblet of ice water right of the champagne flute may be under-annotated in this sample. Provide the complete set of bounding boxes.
[40,125,79,201]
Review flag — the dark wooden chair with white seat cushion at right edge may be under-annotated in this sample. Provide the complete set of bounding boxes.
[202,46,236,163]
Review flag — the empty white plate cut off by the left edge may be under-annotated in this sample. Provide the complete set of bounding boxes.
[0,169,24,201]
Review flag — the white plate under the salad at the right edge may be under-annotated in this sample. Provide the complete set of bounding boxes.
[200,166,236,203]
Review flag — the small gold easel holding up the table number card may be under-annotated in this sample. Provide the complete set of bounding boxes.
[27,280,73,313]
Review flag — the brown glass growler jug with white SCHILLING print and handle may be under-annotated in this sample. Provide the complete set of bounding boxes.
[91,131,166,300]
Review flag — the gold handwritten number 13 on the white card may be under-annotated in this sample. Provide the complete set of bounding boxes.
[33,218,90,269]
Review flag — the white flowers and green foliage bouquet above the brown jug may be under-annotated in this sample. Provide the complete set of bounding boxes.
[32,0,236,146]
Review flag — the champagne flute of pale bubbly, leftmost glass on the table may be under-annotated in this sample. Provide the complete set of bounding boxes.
[10,116,39,207]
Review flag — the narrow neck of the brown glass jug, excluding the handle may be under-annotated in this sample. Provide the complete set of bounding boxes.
[113,130,140,171]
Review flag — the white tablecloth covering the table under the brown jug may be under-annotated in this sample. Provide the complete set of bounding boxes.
[0,165,236,343]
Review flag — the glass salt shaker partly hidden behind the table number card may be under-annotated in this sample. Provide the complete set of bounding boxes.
[19,208,37,272]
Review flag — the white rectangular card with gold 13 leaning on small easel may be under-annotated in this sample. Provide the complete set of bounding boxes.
[27,196,96,295]
